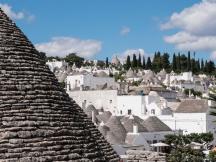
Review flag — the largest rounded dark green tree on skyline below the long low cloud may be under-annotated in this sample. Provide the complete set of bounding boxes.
[65,53,84,67]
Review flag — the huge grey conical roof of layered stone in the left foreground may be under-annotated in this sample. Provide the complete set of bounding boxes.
[0,9,119,162]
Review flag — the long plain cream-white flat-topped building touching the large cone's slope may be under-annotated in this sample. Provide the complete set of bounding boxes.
[67,90,117,114]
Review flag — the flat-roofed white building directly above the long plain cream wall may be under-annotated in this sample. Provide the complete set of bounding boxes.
[66,74,117,91]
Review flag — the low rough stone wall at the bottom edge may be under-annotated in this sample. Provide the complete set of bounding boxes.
[127,150,166,162]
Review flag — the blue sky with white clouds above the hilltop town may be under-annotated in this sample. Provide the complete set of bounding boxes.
[0,0,216,59]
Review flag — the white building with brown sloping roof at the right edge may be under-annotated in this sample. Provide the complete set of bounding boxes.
[159,99,216,142]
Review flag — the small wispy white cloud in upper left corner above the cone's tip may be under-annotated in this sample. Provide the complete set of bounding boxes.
[0,3,35,21]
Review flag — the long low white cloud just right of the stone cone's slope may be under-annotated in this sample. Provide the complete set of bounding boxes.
[35,37,102,58]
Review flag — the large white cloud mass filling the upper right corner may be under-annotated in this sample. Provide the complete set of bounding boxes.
[161,0,216,58]
